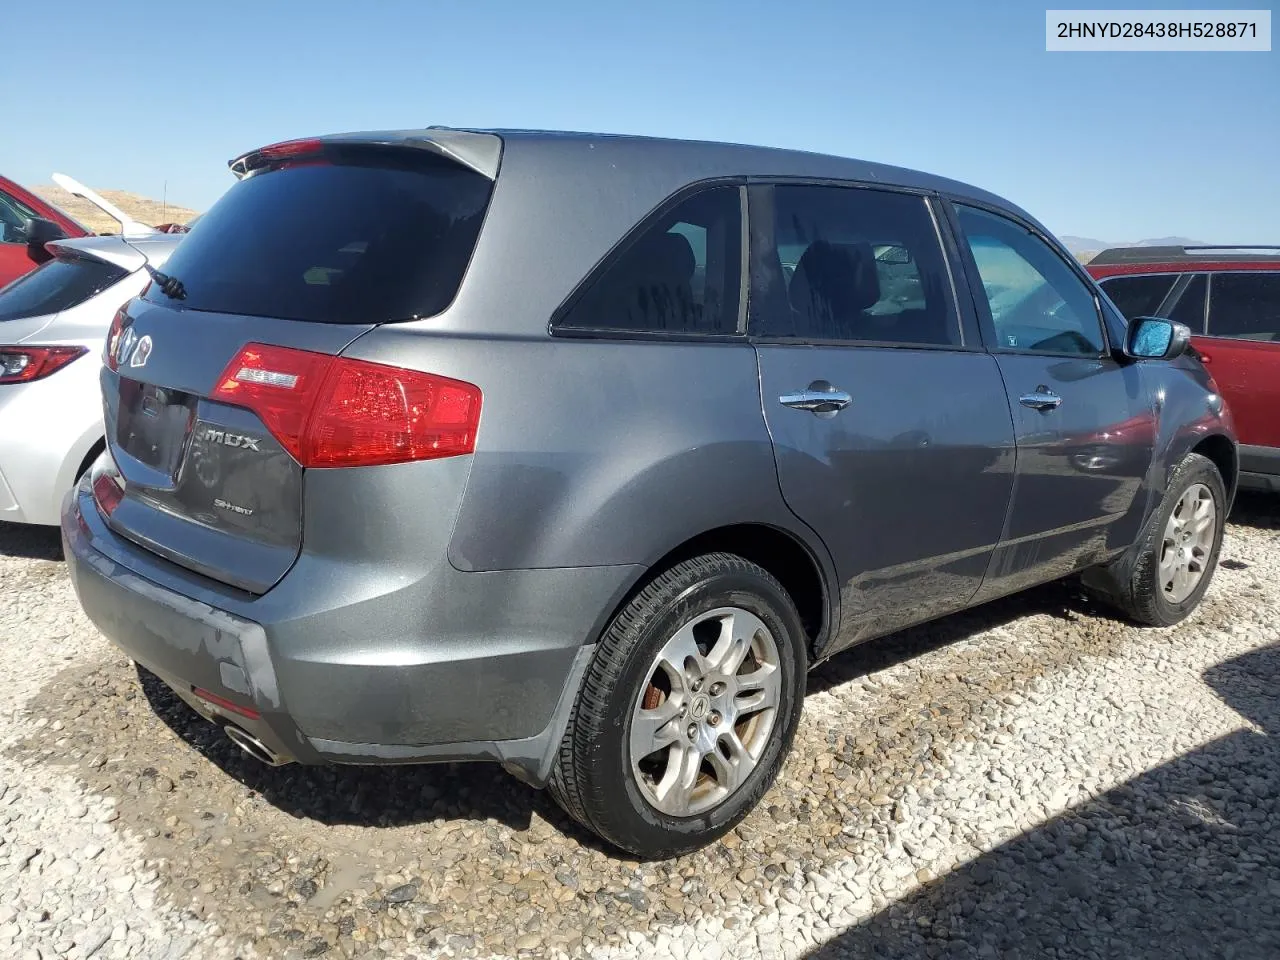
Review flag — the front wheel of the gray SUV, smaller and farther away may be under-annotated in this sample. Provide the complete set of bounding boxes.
[1102,453,1226,627]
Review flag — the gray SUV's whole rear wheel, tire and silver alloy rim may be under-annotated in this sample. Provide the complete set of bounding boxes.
[550,553,806,859]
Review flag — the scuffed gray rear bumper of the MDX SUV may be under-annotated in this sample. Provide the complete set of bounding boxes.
[63,484,639,786]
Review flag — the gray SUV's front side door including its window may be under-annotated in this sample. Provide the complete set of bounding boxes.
[955,205,1156,599]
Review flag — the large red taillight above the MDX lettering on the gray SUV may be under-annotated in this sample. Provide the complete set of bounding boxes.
[212,343,481,467]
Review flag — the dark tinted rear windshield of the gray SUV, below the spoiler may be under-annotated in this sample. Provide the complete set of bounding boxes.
[146,147,493,324]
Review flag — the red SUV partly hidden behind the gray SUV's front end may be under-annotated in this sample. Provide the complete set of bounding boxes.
[1087,247,1280,492]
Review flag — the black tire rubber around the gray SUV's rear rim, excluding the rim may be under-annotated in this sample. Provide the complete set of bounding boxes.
[591,571,805,851]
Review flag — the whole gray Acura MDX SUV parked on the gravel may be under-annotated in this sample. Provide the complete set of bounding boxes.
[63,128,1236,856]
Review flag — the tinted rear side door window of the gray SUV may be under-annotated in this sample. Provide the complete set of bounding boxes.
[753,186,960,346]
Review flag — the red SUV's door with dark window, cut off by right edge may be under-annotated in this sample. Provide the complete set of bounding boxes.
[1197,270,1280,460]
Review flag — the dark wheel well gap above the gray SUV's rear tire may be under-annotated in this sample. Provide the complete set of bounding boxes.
[634,524,828,652]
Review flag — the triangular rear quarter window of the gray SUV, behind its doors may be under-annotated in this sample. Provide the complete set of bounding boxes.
[557,187,742,334]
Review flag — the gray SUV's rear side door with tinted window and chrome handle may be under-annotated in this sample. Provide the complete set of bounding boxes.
[750,183,1014,646]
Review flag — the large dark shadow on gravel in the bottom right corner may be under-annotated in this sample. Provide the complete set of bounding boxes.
[809,645,1280,960]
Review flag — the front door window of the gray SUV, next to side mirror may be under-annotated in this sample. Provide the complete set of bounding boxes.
[956,206,1103,356]
